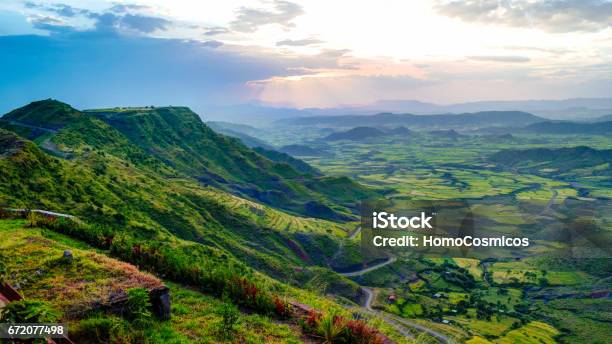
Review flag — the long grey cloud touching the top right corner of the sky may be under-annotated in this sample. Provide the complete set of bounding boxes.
[434,0,612,33]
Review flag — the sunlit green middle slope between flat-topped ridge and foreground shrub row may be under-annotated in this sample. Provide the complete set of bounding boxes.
[0,127,354,282]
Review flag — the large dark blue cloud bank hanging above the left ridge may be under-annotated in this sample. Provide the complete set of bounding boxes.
[0,31,299,114]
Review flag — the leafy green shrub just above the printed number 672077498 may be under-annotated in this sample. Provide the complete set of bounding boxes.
[0,300,59,323]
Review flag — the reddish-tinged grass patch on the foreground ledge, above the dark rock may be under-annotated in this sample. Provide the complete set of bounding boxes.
[0,220,161,318]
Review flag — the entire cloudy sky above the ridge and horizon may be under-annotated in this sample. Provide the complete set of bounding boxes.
[0,0,612,112]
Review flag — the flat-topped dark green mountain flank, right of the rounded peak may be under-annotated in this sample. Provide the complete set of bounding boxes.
[87,107,373,219]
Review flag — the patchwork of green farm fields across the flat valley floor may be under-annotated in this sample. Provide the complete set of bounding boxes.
[255,128,612,343]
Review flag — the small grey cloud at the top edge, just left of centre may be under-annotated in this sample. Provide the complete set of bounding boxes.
[230,0,304,32]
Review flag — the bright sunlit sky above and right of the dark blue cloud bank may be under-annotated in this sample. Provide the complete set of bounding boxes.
[0,0,612,107]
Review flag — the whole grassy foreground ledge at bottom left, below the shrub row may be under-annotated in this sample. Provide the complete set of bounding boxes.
[0,220,332,343]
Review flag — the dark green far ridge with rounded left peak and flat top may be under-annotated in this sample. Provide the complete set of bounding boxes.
[0,100,375,220]
